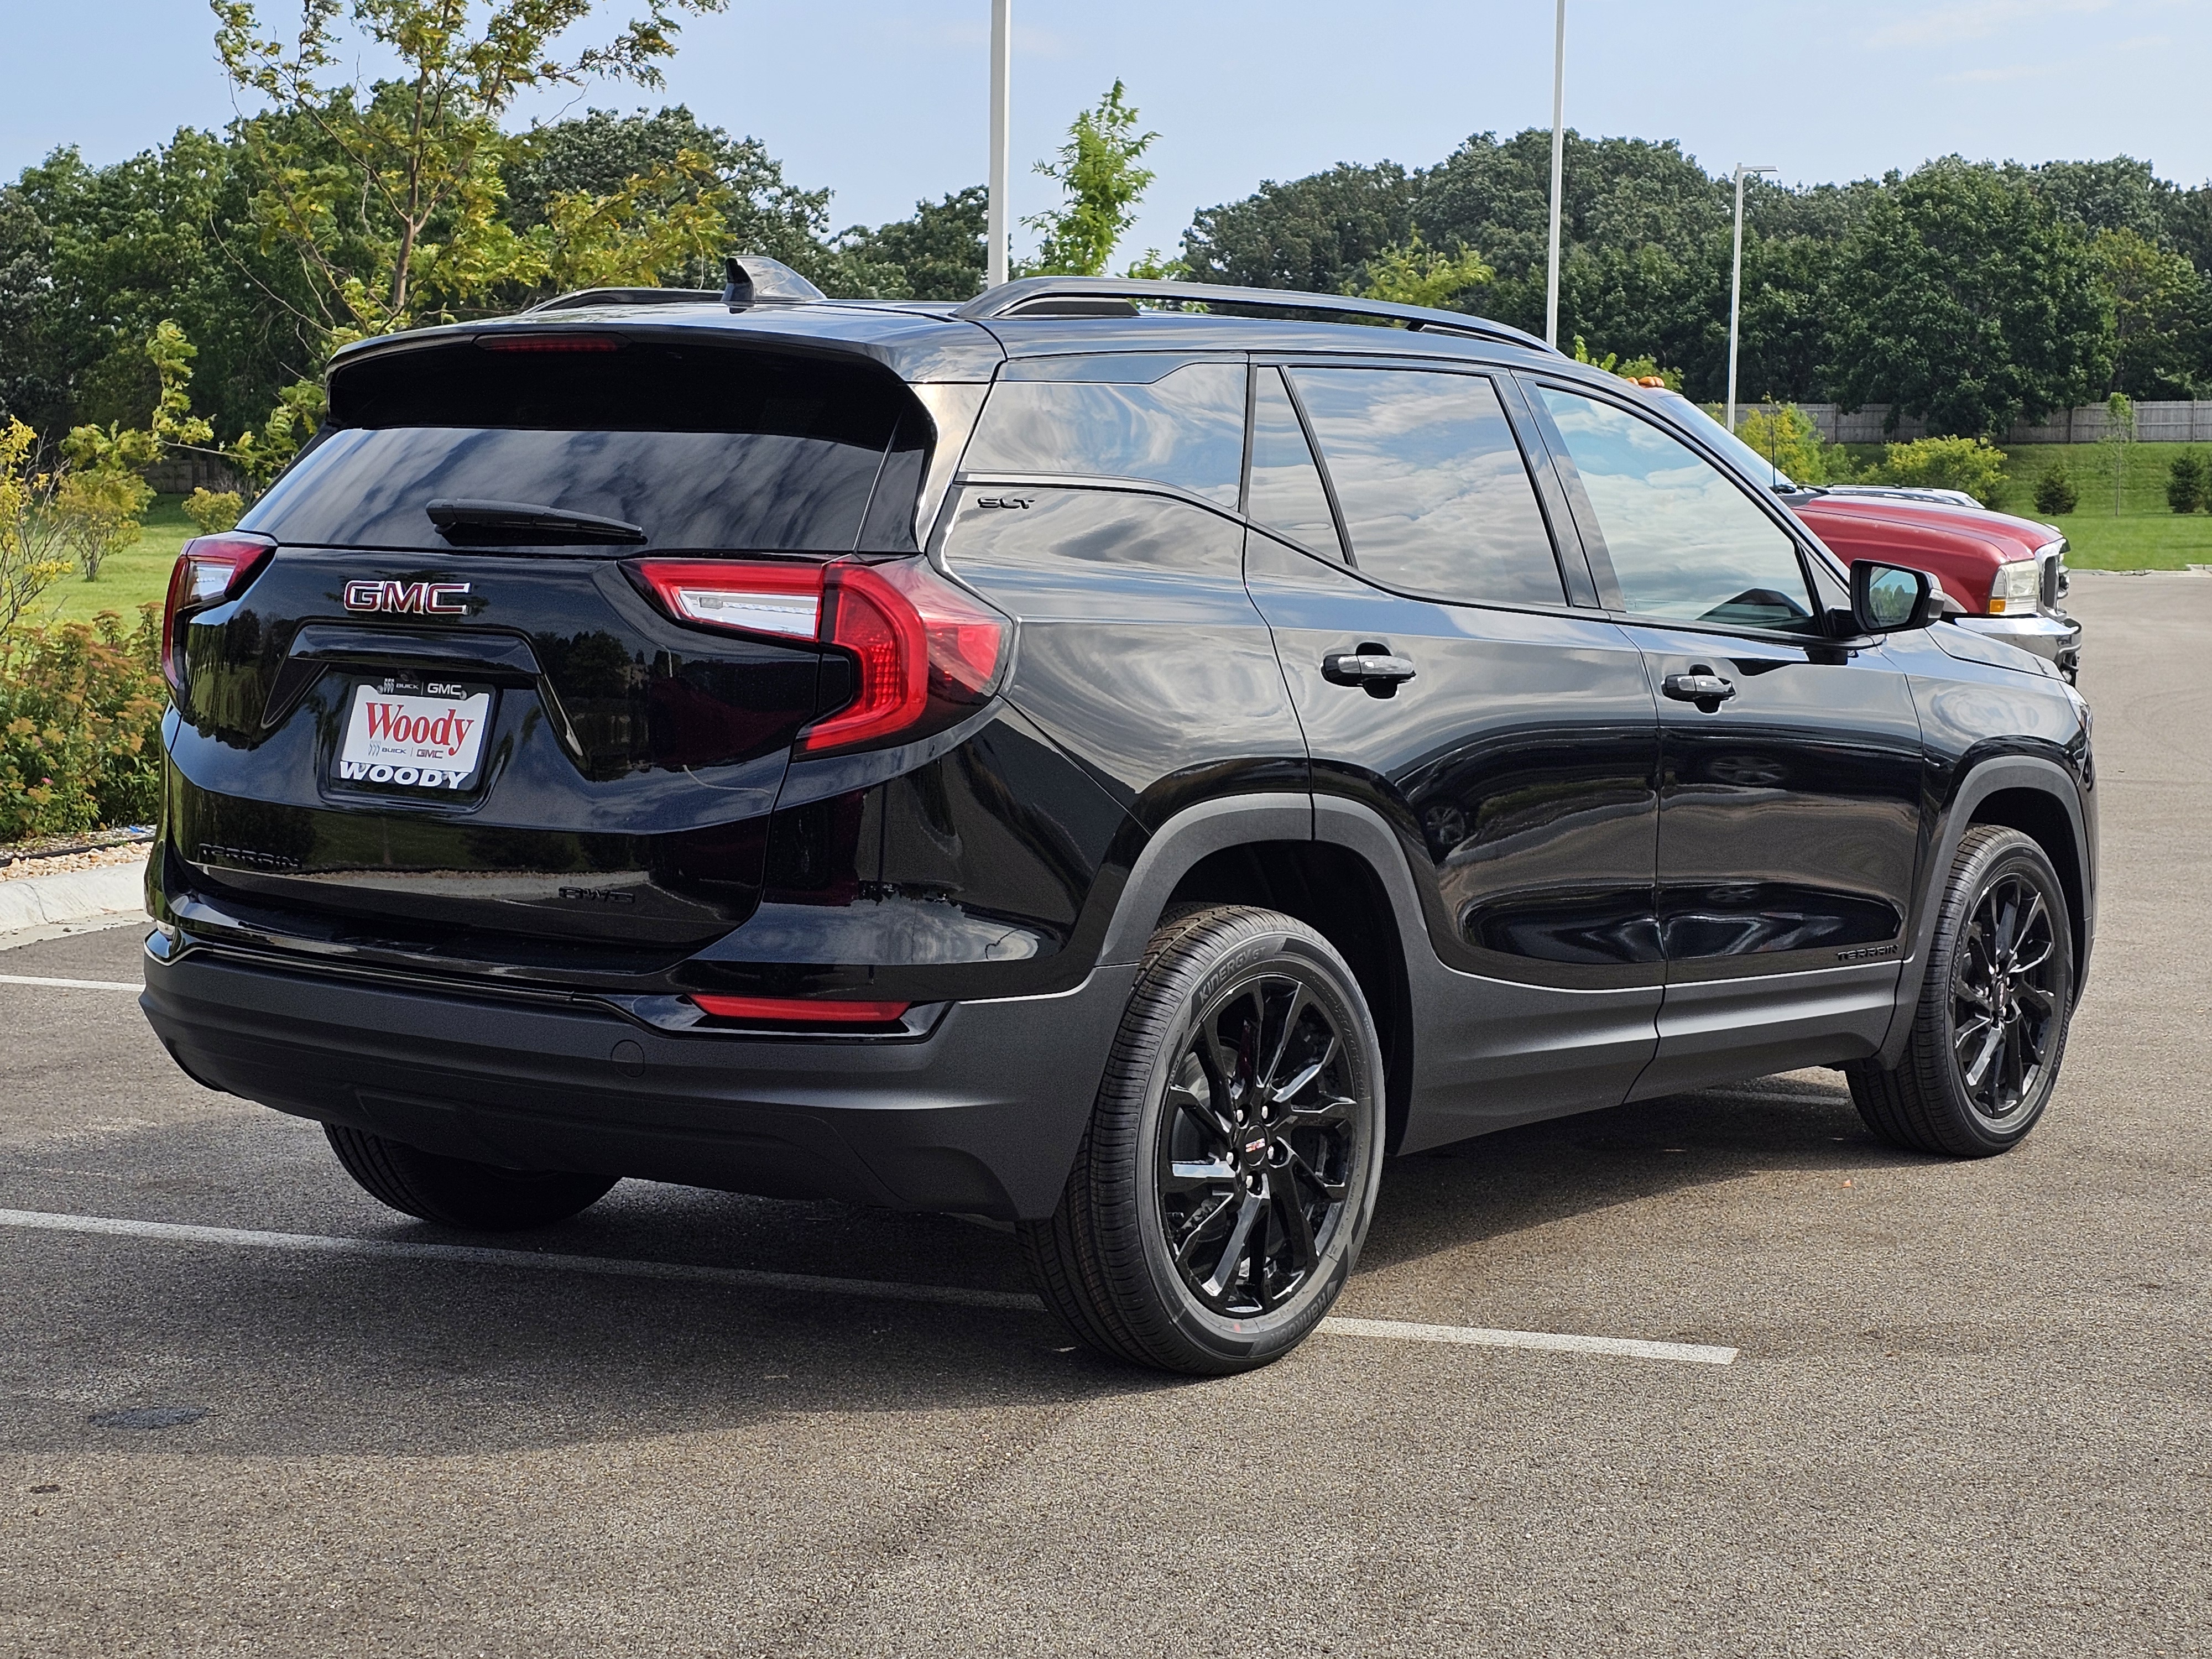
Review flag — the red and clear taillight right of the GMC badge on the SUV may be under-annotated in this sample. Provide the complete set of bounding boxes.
[630,560,1013,754]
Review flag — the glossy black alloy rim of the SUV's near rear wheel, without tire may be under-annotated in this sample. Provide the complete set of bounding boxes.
[1152,971,1358,1318]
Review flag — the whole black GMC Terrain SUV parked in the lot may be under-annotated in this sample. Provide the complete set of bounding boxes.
[144,259,2097,1371]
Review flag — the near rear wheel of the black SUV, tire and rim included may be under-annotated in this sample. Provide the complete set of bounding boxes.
[1020,905,1385,1376]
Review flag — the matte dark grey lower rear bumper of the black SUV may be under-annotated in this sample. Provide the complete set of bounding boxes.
[139,933,1135,1221]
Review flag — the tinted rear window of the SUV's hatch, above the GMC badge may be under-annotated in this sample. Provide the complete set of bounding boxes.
[243,343,929,553]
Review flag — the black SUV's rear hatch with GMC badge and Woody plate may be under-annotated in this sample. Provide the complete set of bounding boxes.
[161,325,931,982]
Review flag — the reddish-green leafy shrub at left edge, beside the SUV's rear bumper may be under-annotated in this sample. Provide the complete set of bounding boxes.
[0,604,168,841]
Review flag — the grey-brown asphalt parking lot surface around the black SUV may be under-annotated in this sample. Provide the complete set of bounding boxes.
[0,575,2212,1657]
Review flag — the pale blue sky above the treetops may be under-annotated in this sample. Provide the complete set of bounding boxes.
[0,0,2212,254]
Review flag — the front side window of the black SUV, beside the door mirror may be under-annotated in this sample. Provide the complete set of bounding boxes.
[1540,385,1818,633]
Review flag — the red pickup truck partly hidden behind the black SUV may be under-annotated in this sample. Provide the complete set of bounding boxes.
[1646,387,2081,679]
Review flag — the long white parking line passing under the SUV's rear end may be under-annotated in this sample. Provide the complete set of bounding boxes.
[0,1210,1736,1365]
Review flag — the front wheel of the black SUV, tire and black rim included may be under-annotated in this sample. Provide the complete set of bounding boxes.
[1845,825,2073,1157]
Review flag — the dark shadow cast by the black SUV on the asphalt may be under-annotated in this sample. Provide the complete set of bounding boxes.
[0,1073,1920,1458]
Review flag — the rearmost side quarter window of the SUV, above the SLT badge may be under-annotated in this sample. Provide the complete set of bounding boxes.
[960,358,1245,511]
